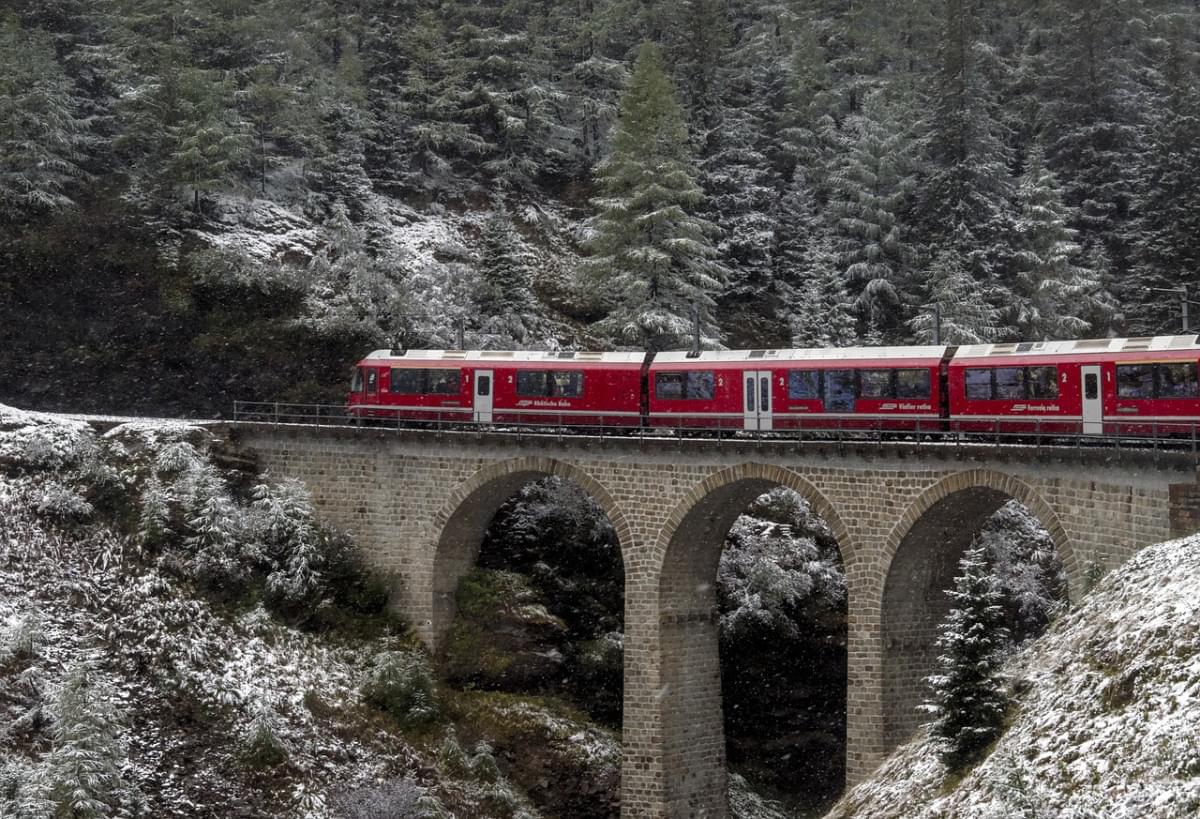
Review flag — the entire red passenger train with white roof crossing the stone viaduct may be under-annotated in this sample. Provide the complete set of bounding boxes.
[347,335,1200,436]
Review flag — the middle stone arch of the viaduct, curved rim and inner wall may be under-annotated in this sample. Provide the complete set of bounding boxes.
[648,462,852,819]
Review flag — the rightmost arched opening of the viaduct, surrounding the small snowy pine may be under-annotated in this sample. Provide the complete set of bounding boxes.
[882,476,1067,749]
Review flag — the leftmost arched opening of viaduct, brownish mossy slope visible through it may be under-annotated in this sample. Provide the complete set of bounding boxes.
[436,462,625,819]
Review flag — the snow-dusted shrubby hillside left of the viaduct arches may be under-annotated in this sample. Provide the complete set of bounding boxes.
[0,405,620,819]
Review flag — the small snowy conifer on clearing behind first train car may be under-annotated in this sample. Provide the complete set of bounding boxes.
[479,208,535,343]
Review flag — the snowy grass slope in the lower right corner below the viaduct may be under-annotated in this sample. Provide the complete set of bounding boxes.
[827,536,1200,819]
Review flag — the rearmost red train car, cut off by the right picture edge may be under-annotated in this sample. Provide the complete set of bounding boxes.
[948,335,1200,436]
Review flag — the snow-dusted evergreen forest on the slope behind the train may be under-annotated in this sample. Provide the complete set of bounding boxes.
[0,0,1200,414]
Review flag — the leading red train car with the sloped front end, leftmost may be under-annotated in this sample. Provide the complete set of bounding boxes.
[347,349,646,428]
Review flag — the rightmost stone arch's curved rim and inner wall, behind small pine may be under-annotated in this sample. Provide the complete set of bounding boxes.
[880,470,1075,751]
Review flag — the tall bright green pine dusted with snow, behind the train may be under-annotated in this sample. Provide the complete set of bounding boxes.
[586,42,726,349]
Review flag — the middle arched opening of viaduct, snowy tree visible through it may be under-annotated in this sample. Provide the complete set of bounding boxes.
[660,465,846,815]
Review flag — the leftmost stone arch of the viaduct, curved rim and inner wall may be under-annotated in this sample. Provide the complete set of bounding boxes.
[426,456,631,647]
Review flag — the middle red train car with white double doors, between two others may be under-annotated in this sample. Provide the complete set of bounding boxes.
[647,346,948,431]
